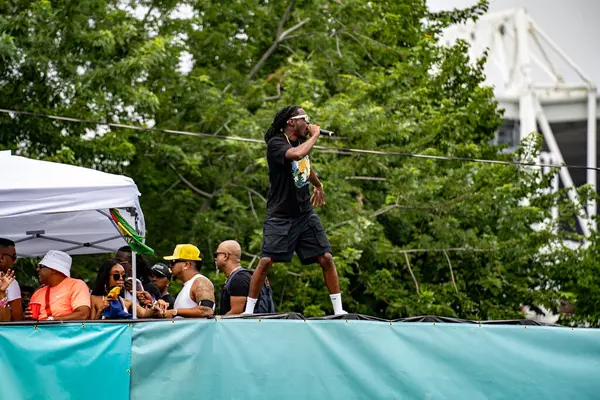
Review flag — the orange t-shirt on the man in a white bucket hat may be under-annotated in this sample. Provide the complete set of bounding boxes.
[30,278,90,320]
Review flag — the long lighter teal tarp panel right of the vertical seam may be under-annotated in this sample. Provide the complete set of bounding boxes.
[132,320,600,399]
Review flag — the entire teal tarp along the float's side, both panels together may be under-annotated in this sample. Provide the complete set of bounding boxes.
[0,319,600,400]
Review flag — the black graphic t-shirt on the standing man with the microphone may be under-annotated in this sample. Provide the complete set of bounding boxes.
[267,134,312,218]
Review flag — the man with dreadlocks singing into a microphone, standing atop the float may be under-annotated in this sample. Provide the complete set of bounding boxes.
[244,106,346,315]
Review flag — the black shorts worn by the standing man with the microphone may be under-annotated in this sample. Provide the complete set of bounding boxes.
[262,210,331,264]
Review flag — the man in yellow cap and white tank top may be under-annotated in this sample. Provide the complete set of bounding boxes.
[158,244,215,318]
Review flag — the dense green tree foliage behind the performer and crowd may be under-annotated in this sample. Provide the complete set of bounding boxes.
[0,0,598,322]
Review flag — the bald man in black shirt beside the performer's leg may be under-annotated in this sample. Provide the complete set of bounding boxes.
[215,240,252,315]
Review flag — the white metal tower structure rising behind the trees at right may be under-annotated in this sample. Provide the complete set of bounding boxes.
[444,8,598,237]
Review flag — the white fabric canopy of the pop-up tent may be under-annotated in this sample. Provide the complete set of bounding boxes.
[0,152,145,257]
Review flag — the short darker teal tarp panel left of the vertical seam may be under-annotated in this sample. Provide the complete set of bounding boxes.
[0,323,131,400]
